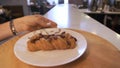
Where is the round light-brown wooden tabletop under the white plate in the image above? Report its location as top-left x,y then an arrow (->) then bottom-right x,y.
0,30 -> 120,68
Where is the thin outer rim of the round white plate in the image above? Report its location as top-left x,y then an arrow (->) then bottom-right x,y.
14,28 -> 87,67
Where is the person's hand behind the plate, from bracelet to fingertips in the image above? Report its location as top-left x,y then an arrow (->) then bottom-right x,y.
13,15 -> 57,32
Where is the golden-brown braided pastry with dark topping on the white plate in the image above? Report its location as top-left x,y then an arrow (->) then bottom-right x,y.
27,28 -> 77,52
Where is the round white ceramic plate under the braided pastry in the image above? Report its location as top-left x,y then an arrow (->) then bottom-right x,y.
14,28 -> 87,67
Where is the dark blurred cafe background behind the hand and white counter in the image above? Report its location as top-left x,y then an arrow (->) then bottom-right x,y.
0,0 -> 120,33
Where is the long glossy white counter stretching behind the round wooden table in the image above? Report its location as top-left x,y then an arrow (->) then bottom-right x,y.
44,4 -> 120,50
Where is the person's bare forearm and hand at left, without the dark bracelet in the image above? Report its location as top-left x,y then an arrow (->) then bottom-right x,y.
0,15 -> 57,40
